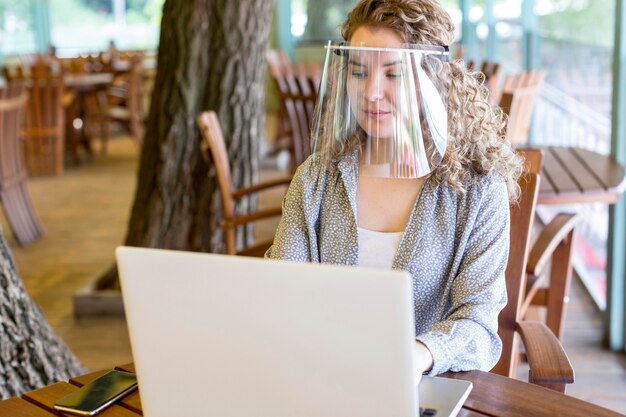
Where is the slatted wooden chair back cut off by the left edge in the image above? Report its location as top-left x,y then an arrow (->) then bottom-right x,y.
0,83 -> 43,246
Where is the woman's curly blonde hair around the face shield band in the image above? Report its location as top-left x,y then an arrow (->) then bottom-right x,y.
342,0 -> 522,201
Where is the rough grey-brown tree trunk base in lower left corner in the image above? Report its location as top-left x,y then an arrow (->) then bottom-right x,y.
0,229 -> 85,399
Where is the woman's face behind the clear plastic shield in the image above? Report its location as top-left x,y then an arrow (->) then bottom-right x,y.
347,26 -> 403,139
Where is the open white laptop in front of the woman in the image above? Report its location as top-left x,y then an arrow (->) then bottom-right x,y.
116,247 -> 472,417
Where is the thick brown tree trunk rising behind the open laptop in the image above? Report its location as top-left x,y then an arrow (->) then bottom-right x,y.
126,0 -> 273,252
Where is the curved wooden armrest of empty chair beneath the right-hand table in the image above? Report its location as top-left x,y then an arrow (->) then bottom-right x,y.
526,213 -> 581,277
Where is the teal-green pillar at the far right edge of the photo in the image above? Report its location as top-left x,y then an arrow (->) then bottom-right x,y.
605,0 -> 626,350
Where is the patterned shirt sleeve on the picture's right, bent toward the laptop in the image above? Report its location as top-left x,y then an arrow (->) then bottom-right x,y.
417,177 -> 510,375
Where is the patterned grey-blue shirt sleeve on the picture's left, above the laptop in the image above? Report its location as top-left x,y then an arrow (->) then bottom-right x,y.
265,158 -> 319,262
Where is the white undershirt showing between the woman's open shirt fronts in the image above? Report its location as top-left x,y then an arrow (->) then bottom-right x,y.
357,227 -> 402,269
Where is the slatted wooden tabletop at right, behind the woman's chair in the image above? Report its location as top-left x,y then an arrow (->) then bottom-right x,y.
537,146 -> 626,204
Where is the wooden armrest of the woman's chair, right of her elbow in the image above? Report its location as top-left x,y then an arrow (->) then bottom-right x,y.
517,321 -> 574,392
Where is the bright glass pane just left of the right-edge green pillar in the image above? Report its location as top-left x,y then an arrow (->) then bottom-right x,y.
534,0 -> 615,308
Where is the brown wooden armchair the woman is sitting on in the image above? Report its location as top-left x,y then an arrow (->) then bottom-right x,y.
492,150 -> 574,392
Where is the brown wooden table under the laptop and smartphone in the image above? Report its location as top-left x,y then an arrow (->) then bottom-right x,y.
0,364 -> 623,417
